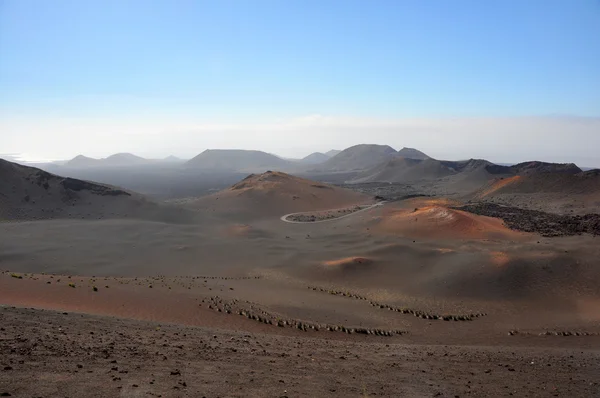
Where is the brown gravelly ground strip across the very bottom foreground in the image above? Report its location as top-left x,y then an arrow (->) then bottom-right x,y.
0,307 -> 600,397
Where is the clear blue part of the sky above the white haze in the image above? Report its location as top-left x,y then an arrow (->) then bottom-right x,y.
0,0 -> 600,162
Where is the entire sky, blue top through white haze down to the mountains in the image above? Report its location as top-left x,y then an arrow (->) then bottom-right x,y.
0,0 -> 600,166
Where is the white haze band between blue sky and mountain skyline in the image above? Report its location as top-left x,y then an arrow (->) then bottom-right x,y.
0,115 -> 600,167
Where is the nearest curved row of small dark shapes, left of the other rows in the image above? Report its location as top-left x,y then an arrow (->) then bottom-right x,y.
202,296 -> 407,337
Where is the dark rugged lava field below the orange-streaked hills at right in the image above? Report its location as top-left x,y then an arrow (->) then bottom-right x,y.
456,202 -> 600,237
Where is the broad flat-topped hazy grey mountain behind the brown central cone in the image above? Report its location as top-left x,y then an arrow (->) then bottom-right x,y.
186,149 -> 292,172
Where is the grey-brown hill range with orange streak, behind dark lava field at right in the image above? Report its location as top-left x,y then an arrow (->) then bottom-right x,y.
347,157 -> 600,214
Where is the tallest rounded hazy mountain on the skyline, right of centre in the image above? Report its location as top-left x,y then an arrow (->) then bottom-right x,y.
315,144 -> 397,171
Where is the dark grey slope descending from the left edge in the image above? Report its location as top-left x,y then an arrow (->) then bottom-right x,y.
0,159 -> 189,222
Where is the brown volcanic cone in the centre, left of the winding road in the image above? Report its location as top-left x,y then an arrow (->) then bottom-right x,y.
185,171 -> 372,220
